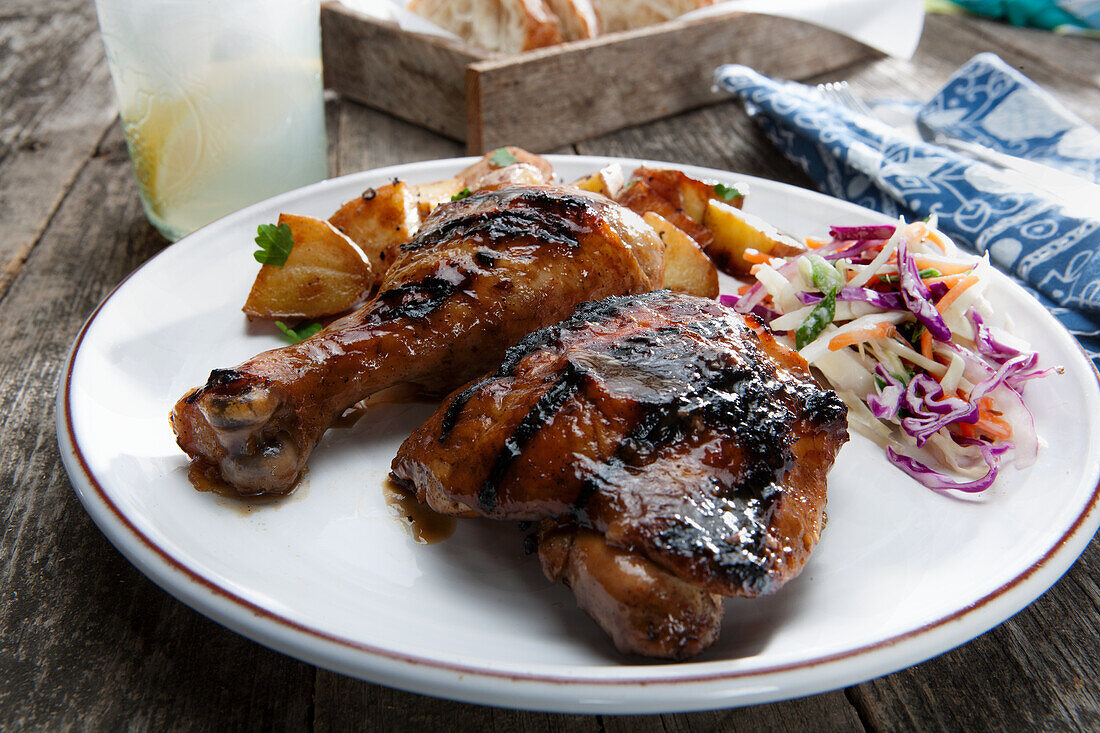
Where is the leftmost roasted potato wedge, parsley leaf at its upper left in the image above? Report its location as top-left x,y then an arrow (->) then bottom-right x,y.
242,214 -> 374,319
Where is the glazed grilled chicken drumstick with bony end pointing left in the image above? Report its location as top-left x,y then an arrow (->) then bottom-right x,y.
171,186 -> 663,494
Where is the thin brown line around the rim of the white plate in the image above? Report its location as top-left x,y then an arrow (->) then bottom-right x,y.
63,232 -> 1100,686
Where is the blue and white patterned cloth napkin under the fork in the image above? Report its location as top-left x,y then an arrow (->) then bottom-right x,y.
715,54 -> 1100,368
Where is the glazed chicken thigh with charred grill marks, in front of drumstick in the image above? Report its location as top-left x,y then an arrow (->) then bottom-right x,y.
393,291 -> 847,658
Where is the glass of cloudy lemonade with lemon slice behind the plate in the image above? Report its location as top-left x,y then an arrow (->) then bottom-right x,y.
96,0 -> 328,241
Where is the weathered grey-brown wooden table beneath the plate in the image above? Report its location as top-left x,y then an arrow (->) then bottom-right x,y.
0,0 -> 1100,732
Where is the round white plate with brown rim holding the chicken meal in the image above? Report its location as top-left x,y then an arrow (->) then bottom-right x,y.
57,156 -> 1100,713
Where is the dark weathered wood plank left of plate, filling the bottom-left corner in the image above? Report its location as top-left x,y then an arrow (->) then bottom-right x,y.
0,125 -> 314,731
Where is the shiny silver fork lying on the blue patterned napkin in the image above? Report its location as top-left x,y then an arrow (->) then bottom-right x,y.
817,81 -> 1100,214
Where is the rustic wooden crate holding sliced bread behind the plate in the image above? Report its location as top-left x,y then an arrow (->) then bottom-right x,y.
321,2 -> 877,153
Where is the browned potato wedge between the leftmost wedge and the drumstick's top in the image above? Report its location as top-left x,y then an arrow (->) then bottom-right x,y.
329,180 -> 420,282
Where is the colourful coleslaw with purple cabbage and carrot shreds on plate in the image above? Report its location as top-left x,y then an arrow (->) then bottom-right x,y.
722,218 -> 1062,493
